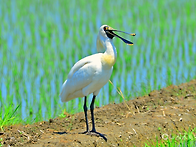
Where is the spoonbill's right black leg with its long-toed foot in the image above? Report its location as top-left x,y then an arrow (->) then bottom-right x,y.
90,95 -> 107,141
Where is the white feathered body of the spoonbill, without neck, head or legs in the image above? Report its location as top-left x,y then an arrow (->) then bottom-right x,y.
60,53 -> 112,102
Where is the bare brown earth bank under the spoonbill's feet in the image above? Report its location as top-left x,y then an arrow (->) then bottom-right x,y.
0,80 -> 196,147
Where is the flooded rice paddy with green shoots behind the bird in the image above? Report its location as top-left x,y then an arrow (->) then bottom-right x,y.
0,0 -> 196,124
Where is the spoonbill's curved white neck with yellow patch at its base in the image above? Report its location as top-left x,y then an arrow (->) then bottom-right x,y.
102,39 -> 117,67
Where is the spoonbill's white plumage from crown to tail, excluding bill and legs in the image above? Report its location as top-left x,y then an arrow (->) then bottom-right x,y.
60,25 -> 116,102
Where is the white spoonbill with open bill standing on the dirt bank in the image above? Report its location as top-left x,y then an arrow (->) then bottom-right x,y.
59,25 -> 136,141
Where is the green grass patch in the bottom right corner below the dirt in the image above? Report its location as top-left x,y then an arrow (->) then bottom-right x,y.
145,128 -> 196,147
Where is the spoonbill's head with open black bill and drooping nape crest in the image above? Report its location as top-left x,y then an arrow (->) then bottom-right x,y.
97,25 -> 136,52
